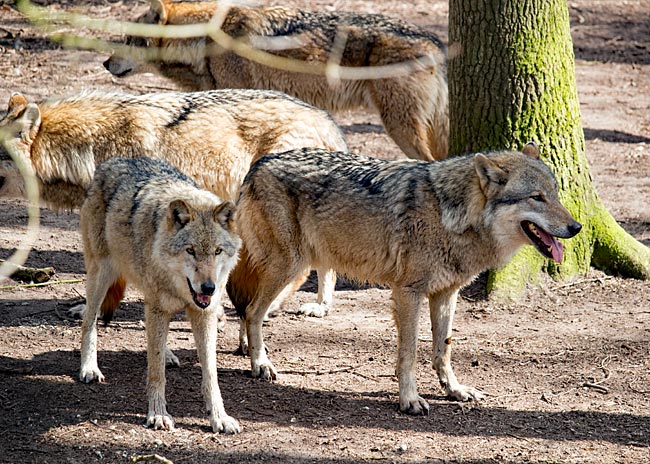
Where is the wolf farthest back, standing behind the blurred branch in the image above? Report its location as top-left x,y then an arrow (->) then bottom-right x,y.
104,0 -> 449,160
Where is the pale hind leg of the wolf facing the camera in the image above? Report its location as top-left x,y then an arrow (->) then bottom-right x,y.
79,258 -> 118,383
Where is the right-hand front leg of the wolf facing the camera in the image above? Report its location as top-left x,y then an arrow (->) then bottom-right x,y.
188,308 -> 241,434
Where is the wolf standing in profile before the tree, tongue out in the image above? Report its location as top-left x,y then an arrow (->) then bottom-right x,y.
227,145 -> 581,415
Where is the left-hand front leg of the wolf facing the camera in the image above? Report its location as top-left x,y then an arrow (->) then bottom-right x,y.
144,301 -> 174,430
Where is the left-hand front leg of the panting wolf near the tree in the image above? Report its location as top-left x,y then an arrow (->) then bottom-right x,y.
392,288 -> 429,415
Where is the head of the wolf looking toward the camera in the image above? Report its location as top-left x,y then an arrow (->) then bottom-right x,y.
157,196 -> 241,309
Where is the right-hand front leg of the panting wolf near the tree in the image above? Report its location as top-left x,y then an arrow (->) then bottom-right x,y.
429,289 -> 484,401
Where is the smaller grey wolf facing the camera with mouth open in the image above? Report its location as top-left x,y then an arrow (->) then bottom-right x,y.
79,158 -> 241,433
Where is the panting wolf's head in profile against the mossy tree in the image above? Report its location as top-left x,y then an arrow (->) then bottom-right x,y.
474,143 -> 582,263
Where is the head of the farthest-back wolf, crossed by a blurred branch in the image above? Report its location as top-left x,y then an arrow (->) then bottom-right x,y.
103,0 -> 218,77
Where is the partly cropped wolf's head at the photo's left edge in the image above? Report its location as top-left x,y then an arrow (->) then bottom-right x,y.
0,93 -> 41,196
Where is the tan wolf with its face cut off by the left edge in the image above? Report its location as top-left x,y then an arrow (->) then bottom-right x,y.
0,90 -> 347,318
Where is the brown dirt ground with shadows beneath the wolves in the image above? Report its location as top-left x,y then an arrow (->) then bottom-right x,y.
0,0 -> 650,464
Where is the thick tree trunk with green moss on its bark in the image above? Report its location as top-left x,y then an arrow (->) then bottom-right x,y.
449,0 -> 650,300
